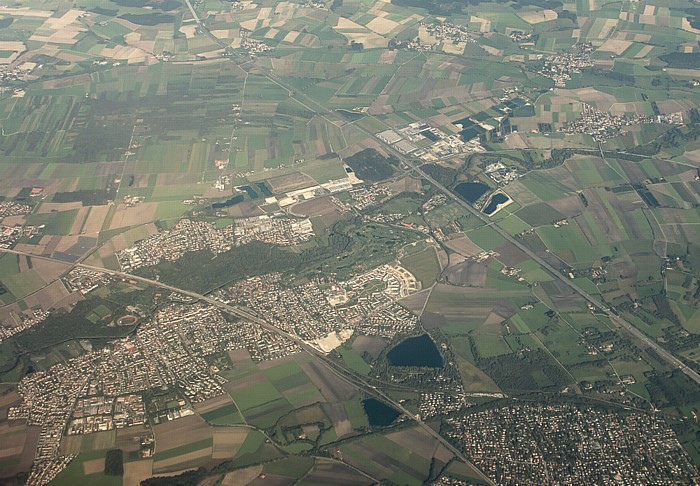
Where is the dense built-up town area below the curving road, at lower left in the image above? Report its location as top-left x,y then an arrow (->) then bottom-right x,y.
8,304 -> 299,484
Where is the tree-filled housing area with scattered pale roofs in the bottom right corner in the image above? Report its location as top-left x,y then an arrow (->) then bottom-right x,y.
447,403 -> 700,485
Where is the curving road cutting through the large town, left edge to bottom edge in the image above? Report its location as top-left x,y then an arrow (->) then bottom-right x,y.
0,249 -> 495,484
